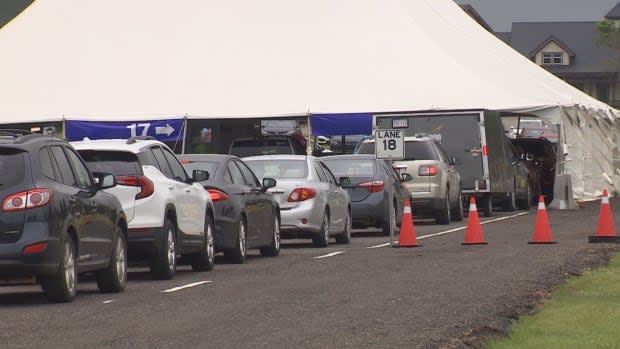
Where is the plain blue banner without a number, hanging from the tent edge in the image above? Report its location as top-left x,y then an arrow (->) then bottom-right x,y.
310,113 -> 372,136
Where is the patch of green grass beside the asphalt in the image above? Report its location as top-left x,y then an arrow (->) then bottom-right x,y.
487,254 -> 620,349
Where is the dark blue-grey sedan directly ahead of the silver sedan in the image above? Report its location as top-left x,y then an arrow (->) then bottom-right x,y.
323,154 -> 411,235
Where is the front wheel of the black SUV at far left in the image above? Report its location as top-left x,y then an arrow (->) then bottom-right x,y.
97,227 -> 127,292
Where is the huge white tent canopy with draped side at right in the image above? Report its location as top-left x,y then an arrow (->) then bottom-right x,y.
0,0 -> 620,198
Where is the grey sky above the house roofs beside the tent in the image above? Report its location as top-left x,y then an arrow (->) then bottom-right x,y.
455,0 -> 620,32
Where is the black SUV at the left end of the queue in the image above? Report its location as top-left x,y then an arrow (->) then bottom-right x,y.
0,131 -> 127,302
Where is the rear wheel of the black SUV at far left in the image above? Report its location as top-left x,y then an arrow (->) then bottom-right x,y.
42,236 -> 77,303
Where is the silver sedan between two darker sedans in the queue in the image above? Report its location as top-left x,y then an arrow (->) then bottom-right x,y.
243,155 -> 351,247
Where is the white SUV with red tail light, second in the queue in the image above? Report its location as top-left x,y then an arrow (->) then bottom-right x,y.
71,137 -> 215,279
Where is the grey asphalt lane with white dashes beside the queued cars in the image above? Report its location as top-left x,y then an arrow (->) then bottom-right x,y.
0,200 -> 620,349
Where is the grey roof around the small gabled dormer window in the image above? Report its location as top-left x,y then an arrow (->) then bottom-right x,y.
510,22 -> 618,74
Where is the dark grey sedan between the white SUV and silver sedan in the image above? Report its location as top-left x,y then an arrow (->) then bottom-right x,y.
180,154 -> 280,263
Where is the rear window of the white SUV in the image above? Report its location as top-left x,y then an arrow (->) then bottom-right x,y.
78,150 -> 142,176
